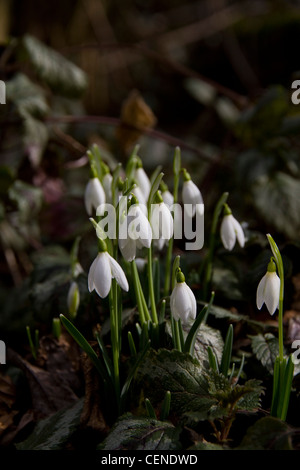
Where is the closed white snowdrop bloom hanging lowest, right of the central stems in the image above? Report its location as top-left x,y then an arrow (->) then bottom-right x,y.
170,270 -> 197,324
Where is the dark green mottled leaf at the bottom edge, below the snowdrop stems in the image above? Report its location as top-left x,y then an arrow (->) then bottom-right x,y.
97,413 -> 181,451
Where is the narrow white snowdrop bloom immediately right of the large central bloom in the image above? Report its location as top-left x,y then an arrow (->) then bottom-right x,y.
150,191 -> 173,248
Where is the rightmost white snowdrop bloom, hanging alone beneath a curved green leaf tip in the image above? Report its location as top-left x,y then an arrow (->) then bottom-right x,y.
256,260 -> 280,315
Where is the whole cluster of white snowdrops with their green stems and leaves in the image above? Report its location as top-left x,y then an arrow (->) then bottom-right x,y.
61,145 -> 293,419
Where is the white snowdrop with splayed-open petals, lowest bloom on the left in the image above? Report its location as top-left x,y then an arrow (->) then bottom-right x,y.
88,240 -> 129,298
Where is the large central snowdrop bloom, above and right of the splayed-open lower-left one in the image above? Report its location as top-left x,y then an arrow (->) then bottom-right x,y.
118,200 -> 152,261
